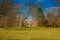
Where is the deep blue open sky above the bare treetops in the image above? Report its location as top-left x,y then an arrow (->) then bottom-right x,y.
13,0 -> 60,8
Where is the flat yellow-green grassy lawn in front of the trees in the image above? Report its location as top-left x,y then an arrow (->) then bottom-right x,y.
0,27 -> 60,40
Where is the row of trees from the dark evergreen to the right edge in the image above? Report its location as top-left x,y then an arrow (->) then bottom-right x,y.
34,8 -> 60,27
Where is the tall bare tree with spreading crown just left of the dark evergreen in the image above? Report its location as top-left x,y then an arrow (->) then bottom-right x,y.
28,2 -> 42,27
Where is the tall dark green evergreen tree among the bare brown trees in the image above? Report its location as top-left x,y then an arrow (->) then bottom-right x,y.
33,8 -> 45,27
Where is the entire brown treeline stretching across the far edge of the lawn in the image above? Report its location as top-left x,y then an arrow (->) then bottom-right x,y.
0,0 -> 60,27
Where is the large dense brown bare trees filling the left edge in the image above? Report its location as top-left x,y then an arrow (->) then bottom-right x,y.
0,0 -> 18,27
